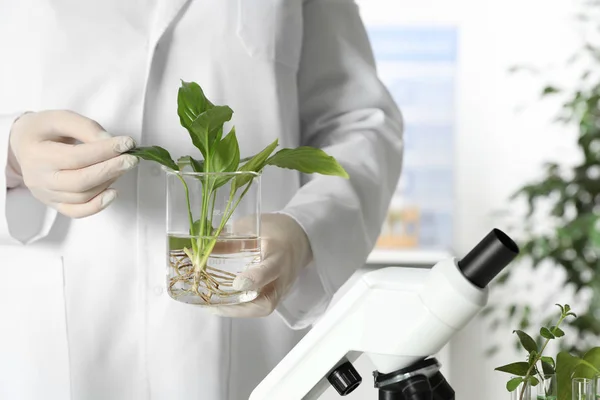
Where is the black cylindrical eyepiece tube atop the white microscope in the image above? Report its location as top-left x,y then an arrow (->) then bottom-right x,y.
458,229 -> 519,289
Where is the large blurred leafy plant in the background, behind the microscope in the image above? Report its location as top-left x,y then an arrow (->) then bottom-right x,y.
488,14 -> 600,351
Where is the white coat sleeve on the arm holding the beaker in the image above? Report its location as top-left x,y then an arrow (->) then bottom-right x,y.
276,0 -> 403,329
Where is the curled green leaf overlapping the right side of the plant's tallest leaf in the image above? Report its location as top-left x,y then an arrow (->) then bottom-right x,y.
189,106 -> 233,159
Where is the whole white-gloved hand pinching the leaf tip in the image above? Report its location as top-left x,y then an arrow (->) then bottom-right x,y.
8,111 -> 138,218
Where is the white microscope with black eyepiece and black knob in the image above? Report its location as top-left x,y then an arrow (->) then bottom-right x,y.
250,229 -> 519,400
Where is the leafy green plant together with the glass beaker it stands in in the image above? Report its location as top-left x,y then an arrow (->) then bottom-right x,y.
129,81 -> 348,305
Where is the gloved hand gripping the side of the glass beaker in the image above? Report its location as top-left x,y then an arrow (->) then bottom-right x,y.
208,214 -> 312,318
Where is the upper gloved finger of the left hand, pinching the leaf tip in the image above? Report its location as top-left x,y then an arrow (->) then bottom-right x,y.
46,136 -> 135,170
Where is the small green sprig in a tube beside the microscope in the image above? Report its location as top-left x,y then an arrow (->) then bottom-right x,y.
496,304 -> 576,400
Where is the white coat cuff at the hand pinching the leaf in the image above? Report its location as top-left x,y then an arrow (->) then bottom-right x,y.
0,113 -> 57,246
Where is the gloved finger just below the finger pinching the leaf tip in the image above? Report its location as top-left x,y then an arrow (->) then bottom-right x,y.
49,154 -> 139,192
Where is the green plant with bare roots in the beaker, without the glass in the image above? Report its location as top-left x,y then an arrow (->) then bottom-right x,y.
129,81 -> 348,303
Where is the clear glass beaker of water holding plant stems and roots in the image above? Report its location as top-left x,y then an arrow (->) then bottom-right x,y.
163,167 -> 261,306
